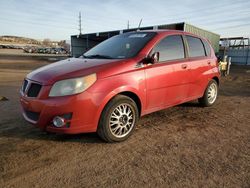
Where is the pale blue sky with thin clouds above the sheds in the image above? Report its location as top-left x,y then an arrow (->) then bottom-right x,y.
0,0 -> 250,40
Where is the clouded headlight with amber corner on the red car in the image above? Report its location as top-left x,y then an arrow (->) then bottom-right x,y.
49,74 -> 96,97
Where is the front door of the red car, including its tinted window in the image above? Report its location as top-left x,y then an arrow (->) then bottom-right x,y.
145,35 -> 189,112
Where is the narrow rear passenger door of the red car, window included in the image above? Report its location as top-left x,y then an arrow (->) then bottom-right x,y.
185,35 -> 211,99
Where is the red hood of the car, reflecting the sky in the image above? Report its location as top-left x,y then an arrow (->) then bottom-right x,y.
27,58 -> 127,85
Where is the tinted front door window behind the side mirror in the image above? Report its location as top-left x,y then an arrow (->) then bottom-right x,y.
154,35 -> 185,62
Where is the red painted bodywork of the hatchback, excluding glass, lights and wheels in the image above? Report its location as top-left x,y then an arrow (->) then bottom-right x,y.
20,31 -> 219,134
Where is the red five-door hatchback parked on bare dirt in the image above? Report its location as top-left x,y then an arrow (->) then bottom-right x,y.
20,30 -> 220,142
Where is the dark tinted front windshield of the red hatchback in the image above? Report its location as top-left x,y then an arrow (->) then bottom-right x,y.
83,32 -> 156,59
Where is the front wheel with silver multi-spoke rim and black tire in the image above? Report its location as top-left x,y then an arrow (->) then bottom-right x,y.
97,95 -> 139,142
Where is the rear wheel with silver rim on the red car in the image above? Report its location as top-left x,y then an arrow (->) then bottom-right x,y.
198,80 -> 218,107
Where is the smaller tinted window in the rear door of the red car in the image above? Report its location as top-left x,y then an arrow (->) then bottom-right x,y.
186,36 -> 205,57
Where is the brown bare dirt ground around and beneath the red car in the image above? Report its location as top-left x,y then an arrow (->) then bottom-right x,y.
0,56 -> 250,188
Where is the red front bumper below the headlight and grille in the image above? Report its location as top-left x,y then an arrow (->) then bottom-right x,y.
20,92 -> 98,134
